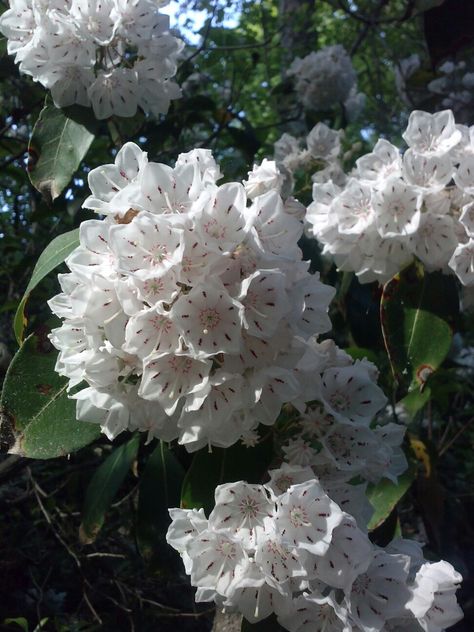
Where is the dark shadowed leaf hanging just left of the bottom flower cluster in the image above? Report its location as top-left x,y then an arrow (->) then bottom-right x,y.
136,441 -> 184,563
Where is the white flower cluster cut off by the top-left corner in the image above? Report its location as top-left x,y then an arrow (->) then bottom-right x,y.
0,0 -> 183,119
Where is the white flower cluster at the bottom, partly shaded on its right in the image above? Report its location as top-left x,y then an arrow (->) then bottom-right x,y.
167,478 -> 462,632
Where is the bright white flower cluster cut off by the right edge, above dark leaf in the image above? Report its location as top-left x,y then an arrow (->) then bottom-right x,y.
306,110 -> 474,285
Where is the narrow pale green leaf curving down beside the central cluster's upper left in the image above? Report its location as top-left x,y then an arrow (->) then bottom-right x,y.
13,228 -> 79,344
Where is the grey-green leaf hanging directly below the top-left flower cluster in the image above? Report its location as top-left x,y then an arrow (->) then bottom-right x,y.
28,97 -> 94,202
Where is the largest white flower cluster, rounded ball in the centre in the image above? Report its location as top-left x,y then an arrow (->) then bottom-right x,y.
49,143 -> 340,450
